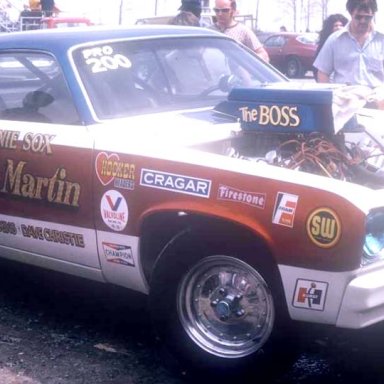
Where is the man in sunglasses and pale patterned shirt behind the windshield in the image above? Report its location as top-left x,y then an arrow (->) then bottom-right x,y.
212,0 -> 269,61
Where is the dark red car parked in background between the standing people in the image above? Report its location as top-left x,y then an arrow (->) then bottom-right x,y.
264,32 -> 318,78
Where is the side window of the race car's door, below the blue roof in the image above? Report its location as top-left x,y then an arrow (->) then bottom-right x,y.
0,52 -> 80,124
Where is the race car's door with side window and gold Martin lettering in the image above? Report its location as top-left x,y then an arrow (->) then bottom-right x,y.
0,51 -> 100,274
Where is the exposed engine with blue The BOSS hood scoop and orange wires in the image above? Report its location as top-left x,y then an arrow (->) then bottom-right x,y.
215,83 -> 384,189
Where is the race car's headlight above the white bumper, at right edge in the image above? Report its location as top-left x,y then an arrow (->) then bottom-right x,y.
362,211 -> 384,265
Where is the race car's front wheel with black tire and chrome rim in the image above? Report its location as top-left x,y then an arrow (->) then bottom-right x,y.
150,232 -> 297,379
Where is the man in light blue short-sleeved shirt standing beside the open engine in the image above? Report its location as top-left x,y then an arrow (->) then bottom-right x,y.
314,0 -> 384,87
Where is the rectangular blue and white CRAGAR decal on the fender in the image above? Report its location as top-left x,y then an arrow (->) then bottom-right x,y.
140,168 -> 212,198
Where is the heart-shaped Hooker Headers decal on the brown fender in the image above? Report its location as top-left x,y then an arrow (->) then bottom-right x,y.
95,152 -> 135,190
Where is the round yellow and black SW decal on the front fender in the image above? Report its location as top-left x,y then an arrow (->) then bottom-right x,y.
307,208 -> 341,248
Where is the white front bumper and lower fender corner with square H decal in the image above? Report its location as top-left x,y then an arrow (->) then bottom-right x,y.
279,262 -> 384,328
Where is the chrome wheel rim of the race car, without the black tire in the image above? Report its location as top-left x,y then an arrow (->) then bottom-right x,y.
177,256 -> 275,358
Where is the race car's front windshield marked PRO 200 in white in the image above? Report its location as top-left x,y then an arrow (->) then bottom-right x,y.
73,37 -> 286,119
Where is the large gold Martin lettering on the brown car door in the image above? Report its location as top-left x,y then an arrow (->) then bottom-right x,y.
0,159 -> 81,207
